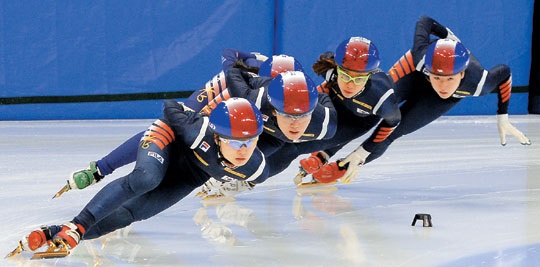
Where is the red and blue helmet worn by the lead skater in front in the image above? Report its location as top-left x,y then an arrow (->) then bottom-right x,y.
209,97 -> 264,139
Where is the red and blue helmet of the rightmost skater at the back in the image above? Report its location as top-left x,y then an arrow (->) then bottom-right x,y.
424,39 -> 470,76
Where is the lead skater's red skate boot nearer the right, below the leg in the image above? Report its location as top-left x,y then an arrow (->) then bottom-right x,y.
32,222 -> 85,259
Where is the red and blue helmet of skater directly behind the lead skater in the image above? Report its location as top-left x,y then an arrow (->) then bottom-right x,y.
268,71 -> 319,116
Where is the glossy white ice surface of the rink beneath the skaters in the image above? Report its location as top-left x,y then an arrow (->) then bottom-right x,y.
0,115 -> 540,267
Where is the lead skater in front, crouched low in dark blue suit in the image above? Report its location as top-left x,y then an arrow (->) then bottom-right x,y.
8,98 -> 268,258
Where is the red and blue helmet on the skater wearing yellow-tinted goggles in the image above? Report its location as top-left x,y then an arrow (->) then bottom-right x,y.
334,37 -> 381,72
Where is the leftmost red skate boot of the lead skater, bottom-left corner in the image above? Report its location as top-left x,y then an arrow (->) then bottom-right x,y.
6,225 -> 61,258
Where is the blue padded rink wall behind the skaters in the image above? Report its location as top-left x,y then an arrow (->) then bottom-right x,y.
0,0 -> 534,120
